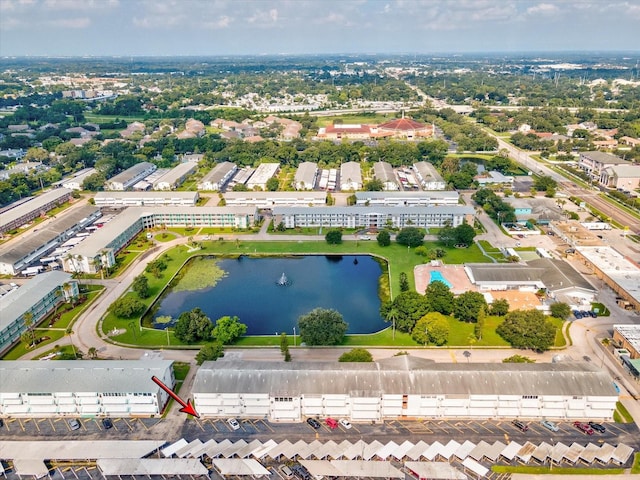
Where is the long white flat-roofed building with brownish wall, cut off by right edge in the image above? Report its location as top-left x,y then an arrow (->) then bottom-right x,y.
575,246 -> 640,310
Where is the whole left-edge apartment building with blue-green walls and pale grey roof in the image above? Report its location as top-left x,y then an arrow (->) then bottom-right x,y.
0,271 -> 79,354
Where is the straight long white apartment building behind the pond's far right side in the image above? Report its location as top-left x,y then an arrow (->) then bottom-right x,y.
273,206 -> 475,230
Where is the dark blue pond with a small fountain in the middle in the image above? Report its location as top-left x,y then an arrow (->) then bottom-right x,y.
154,255 -> 387,335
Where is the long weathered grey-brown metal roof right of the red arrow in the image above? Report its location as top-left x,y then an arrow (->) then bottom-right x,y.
192,356 -> 618,397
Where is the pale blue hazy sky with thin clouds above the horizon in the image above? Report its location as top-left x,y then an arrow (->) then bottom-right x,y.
0,0 -> 640,56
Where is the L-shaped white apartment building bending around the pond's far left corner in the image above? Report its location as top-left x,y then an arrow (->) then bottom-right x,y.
62,206 -> 258,273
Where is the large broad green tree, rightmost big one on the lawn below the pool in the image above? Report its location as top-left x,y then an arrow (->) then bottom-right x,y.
496,310 -> 556,352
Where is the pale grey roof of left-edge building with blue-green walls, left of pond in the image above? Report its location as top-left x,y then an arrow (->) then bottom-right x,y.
0,270 -> 72,330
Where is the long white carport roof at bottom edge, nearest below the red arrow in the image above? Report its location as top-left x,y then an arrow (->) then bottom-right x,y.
97,458 -> 209,478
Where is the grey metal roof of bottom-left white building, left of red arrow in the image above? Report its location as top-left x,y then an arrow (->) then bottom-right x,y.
0,360 -> 173,394
